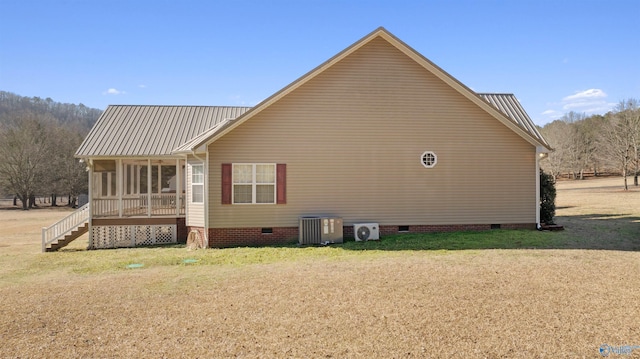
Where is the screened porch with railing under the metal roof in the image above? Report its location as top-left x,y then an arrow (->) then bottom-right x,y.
89,159 -> 185,218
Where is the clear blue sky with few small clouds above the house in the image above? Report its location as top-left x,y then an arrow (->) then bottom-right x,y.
0,0 -> 640,126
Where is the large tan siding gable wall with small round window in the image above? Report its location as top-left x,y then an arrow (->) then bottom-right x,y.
208,39 -> 536,228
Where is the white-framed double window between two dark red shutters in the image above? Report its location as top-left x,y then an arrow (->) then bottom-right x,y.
233,163 -> 276,204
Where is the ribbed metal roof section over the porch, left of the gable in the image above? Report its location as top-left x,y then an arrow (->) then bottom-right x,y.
76,105 -> 251,157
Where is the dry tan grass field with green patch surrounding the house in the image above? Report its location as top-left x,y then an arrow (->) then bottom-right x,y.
0,178 -> 640,358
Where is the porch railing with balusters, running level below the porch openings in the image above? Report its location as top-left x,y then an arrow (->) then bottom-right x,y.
92,193 -> 185,217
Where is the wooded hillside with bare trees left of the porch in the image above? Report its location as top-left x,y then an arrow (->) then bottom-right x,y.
0,91 -> 102,209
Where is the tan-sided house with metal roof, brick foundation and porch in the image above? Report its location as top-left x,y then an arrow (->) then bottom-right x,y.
43,28 -> 550,252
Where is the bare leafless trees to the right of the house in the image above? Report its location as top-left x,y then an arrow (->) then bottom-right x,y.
540,98 -> 640,190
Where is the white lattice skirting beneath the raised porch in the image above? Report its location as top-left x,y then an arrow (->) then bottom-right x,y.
90,224 -> 178,249
